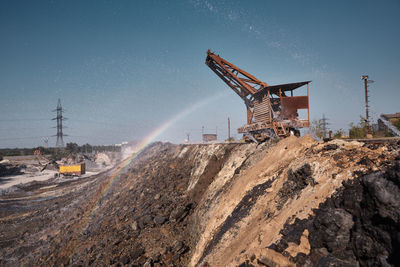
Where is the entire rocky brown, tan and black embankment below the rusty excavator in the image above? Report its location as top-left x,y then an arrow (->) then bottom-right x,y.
0,136 -> 400,266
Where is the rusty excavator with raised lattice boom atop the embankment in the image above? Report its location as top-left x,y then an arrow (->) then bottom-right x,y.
206,50 -> 311,143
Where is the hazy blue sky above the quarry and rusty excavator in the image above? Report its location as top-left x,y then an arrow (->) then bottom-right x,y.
0,0 -> 400,148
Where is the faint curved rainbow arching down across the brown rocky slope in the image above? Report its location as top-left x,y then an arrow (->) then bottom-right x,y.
67,93 -> 224,259
